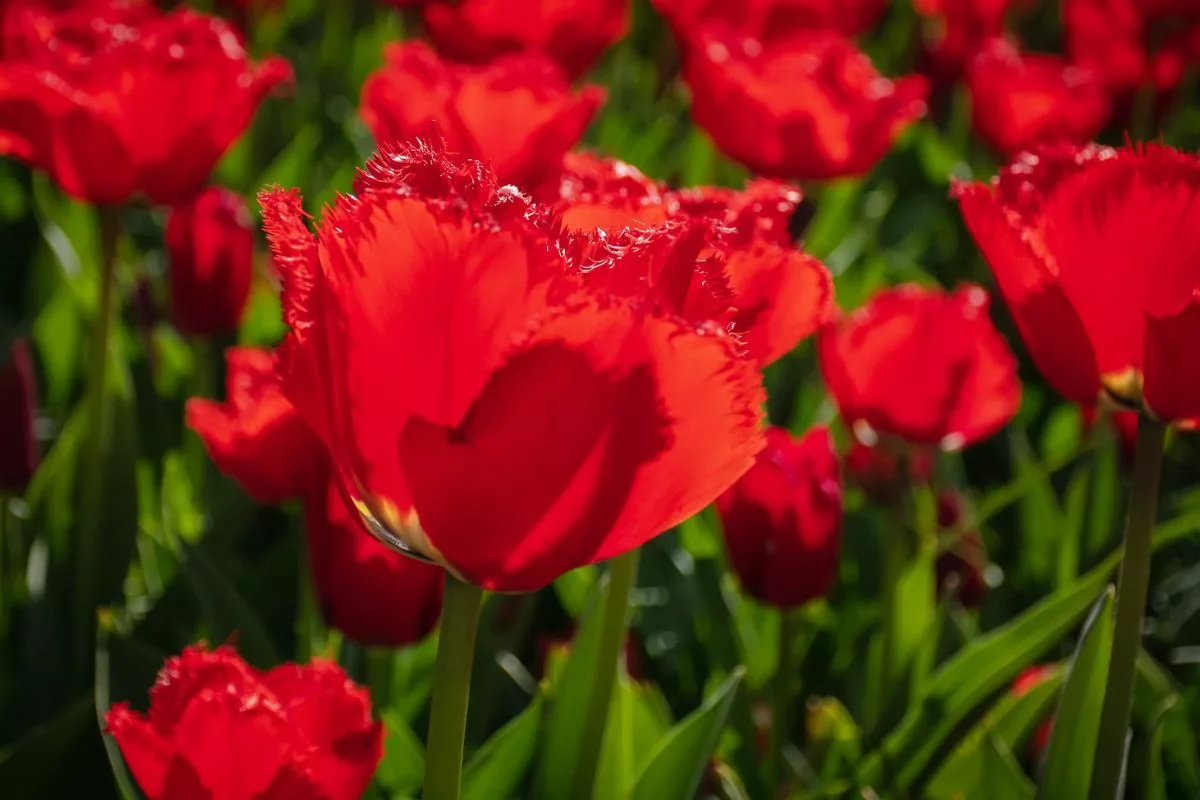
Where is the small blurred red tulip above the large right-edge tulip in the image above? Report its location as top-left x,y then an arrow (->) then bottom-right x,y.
967,38 -> 1112,156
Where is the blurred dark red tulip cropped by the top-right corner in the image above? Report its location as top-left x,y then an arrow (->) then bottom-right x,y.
1063,0 -> 1200,98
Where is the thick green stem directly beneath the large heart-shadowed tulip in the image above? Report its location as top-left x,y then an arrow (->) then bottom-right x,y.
421,572 -> 484,800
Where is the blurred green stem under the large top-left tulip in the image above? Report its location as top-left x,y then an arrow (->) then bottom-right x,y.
73,205 -> 121,682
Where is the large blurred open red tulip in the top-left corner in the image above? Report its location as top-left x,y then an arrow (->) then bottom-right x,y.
0,0 -> 290,204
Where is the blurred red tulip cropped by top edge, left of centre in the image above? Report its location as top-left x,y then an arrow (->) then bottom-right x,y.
422,0 -> 629,77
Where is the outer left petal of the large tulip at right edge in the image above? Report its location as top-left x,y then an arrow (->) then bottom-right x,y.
954,184 -> 1100,407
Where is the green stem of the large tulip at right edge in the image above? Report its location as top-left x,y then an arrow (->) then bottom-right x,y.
1091,416 -> 1166,800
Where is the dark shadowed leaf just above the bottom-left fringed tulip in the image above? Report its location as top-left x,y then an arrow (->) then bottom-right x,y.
180,543 -> 280,669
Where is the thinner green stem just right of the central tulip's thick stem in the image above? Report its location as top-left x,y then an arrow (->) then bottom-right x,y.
568,549 -> 640,800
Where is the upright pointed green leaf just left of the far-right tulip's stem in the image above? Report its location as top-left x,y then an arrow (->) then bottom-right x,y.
1038,587 -> 1116,798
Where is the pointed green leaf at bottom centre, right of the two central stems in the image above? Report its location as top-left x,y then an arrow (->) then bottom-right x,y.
629,667 -> 745,800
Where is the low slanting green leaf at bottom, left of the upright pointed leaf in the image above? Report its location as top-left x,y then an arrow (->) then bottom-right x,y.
925,669 -> 1063,800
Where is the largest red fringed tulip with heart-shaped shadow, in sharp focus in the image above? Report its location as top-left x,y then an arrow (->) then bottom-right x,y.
262,137 -> 763,591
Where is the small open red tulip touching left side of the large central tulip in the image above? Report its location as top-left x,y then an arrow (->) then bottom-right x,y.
187,348 -> 329,504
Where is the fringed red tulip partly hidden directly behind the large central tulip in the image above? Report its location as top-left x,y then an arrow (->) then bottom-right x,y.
554,152 -> 833,365
